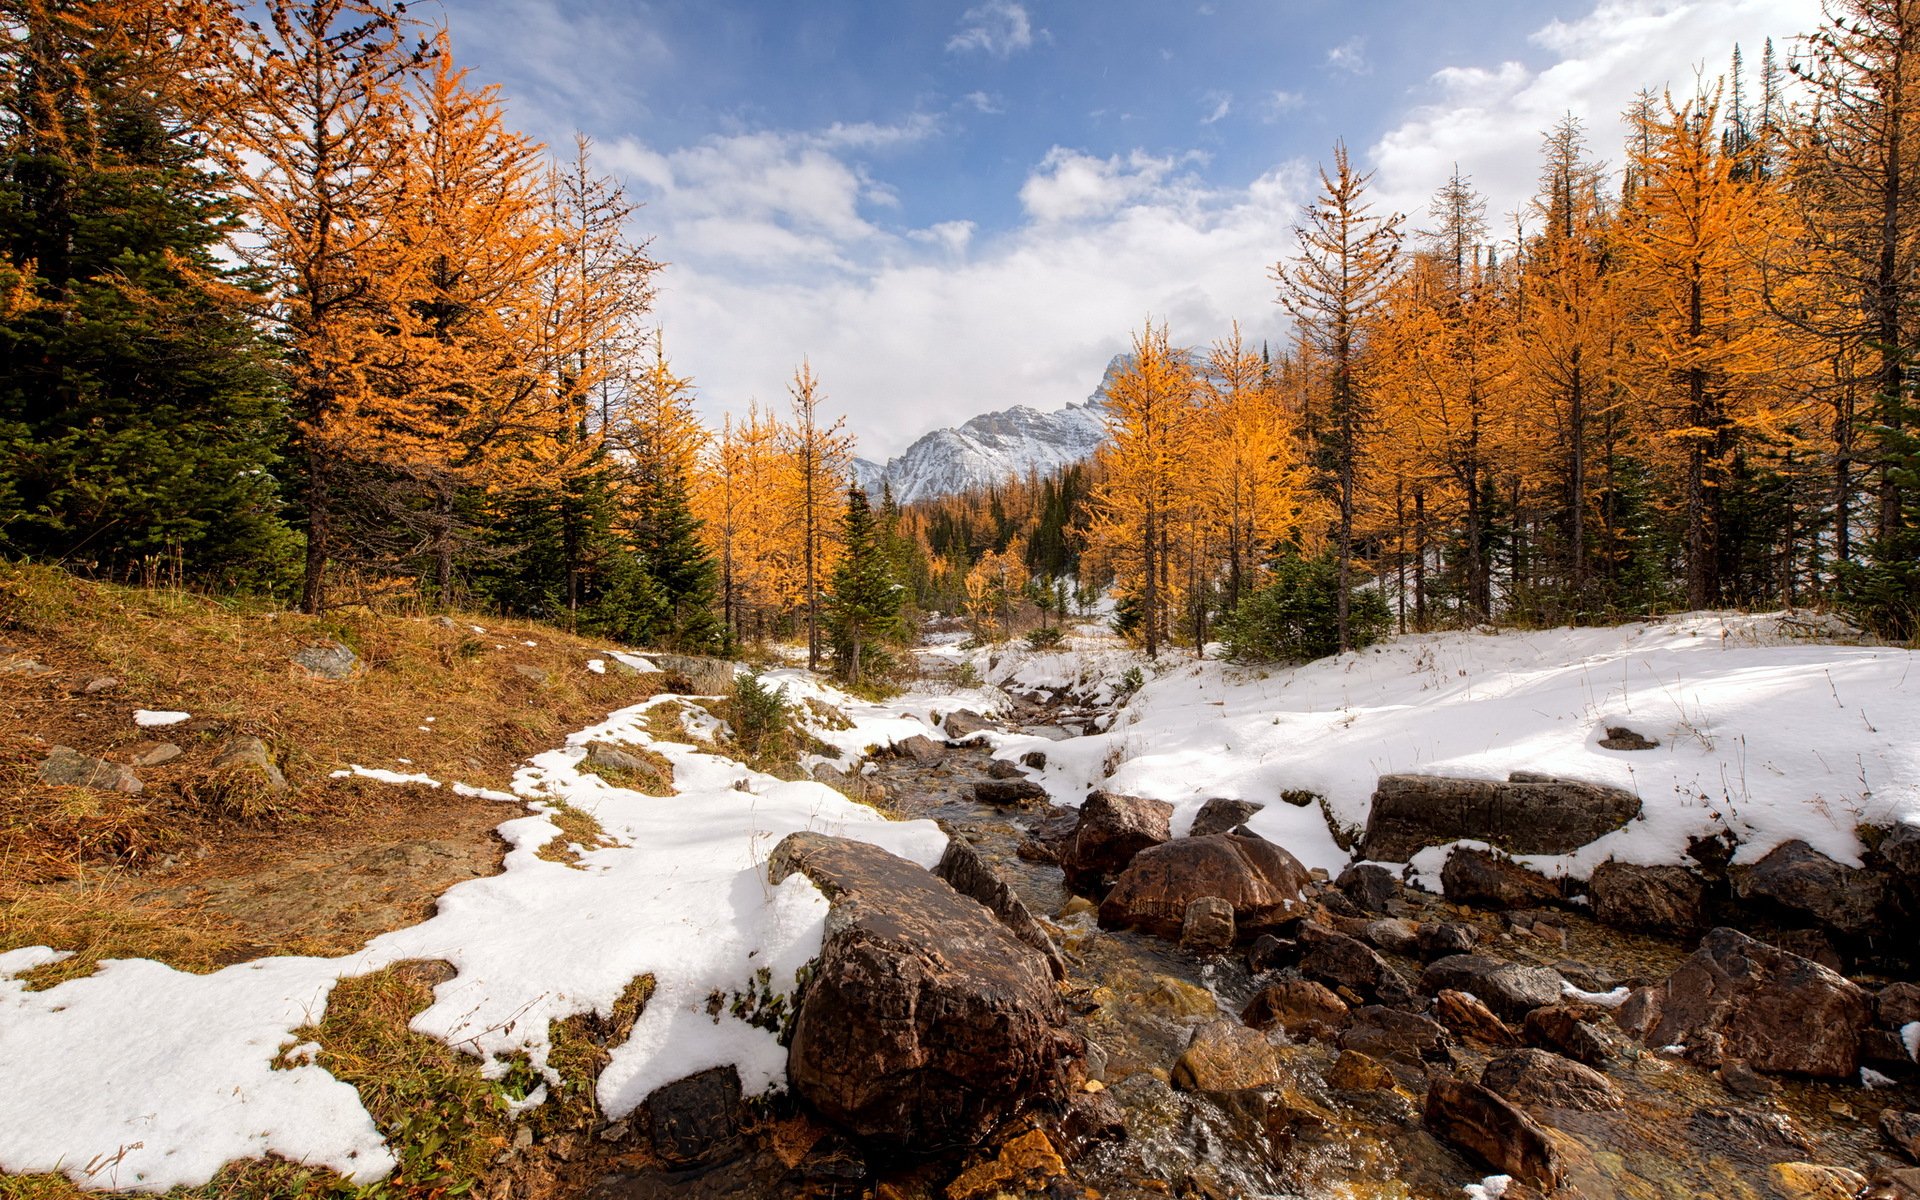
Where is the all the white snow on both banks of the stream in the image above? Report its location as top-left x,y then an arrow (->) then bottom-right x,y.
0,614 -> 1920,1190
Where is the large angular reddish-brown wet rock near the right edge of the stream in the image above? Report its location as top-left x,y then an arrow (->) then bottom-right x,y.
1619,929 -> 1870,1079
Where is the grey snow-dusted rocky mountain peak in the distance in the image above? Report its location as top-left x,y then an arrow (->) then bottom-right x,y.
852,355 -> 1127,505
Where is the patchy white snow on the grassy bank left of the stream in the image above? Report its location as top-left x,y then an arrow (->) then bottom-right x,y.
0,655 -> 952,1190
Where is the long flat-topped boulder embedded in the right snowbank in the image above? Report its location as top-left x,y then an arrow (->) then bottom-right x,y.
1361,776 -> 1640,862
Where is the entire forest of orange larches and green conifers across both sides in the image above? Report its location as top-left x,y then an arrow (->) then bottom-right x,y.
0,0 -> 1920,674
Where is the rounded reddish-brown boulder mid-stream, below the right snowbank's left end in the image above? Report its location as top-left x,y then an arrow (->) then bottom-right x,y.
1100,833 -> 1309,937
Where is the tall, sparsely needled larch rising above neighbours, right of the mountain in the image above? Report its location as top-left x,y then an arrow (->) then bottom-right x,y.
1273,142 -> 1402,649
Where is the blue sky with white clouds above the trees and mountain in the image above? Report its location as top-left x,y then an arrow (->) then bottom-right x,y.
439,0 -> 1820,459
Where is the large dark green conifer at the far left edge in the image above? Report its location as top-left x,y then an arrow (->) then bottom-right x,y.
0,0 -> 294,588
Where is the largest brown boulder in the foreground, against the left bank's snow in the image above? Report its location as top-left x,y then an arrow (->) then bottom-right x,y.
768,831 -> 1081,1152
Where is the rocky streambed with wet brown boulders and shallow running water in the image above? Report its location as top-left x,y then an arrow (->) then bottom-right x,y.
595,679 -> 1920,1200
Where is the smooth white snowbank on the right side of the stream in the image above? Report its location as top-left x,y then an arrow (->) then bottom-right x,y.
973,614 -> 1920,877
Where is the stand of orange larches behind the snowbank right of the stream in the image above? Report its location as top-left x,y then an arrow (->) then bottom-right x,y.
1087,11 -> 1920,649
